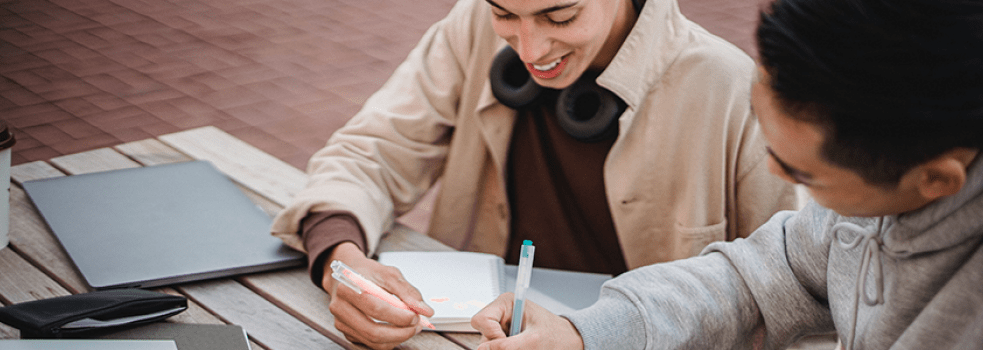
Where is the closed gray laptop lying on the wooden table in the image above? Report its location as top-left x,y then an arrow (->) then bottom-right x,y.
23,161 -> 306,290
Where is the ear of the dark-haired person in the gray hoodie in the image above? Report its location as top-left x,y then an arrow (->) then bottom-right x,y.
915,148 -> 978,200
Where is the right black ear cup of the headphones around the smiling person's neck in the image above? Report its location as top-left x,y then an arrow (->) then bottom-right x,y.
556,73 -> 627,142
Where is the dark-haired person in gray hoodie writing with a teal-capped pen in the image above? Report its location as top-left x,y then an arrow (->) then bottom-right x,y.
471,0 -> 983,350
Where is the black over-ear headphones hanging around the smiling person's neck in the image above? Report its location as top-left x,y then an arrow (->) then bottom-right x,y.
489,0 -> 645,142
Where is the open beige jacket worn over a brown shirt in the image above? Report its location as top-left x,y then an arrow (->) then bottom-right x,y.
272,0 -> 795,268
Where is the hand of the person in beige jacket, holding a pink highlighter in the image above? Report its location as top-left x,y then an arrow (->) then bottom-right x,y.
321,242 -> 433,350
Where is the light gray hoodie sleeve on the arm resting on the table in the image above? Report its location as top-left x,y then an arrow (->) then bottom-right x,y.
567,202 -> 833,350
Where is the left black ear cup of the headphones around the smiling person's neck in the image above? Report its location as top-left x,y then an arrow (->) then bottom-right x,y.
488,46 -> 543,109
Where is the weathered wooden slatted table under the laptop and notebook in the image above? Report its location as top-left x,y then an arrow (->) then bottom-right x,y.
0,127 -> 479,350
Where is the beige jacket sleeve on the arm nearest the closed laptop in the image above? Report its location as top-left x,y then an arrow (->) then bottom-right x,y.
271,0 -> 487,255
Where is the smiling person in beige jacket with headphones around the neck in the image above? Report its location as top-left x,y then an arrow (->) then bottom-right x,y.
273,0 -> 796,349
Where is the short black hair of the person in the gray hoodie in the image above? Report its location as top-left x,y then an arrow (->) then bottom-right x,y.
757,0 -> 983,187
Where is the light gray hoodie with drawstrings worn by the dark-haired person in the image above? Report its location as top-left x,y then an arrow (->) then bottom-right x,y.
567,156 -> 983,350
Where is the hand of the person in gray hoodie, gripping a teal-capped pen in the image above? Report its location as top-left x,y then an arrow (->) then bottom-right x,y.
471,293 -> 584,350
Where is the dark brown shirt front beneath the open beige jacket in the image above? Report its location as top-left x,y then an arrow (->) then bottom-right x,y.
505,92 -> 628,275
